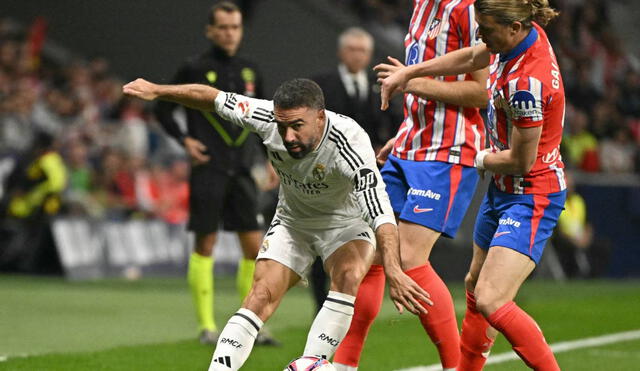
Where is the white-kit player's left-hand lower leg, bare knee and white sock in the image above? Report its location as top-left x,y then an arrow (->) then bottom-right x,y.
209,259 -> 300,371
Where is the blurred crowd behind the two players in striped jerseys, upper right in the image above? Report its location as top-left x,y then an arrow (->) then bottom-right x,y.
338,0 -> 640,173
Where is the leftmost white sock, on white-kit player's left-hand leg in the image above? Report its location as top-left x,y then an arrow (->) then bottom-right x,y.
209,308 -> 263,371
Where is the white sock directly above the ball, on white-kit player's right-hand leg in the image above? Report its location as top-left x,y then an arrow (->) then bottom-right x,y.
303,291 -> 356,359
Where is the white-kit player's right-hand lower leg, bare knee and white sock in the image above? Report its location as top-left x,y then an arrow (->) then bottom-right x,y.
304,240 -> 374,359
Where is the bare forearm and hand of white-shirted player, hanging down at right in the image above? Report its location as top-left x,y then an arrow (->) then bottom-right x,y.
376,223 -> 433,315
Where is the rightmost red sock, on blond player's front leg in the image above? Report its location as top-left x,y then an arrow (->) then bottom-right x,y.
487,301 -> 560,371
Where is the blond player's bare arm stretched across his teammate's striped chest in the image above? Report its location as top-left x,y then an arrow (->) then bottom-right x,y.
374,43 -> 490,110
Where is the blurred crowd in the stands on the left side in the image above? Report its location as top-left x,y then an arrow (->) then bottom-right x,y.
0,19 -> 189,224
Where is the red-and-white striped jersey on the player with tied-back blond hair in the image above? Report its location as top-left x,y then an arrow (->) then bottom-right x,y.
487,23 -> 566,194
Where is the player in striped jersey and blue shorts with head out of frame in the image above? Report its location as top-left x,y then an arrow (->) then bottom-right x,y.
334,0 -> 488,370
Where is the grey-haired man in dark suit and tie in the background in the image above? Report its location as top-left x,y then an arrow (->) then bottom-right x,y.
312,27 -> 402,150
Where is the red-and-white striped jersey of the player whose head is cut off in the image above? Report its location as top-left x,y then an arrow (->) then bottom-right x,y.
392,0 -> 484,166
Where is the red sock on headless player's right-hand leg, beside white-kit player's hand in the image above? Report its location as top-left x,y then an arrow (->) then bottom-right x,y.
405,263 -> 460,369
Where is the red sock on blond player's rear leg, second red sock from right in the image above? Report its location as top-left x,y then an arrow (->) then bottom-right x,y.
458,291 -> 494,371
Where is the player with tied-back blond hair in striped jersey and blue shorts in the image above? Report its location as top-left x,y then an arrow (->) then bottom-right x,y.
381,0 -> 566,371
